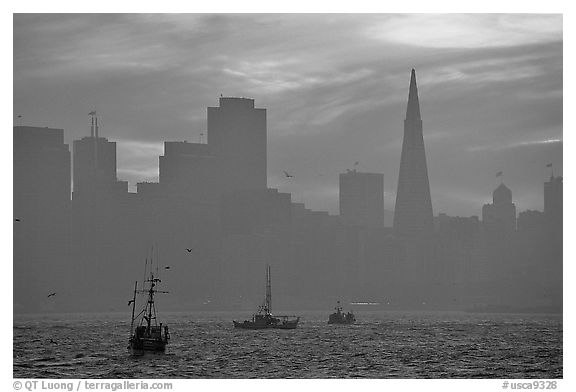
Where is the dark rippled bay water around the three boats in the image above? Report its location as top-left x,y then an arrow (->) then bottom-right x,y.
13,311 -> 562,379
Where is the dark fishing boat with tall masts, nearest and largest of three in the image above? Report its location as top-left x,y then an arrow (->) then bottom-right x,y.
128,258 -> 170,355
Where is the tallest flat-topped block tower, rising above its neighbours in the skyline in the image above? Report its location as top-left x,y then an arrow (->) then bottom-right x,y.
208,97 -> 267,190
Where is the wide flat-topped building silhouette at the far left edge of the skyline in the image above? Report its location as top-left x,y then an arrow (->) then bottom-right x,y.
13,126 -> 70,311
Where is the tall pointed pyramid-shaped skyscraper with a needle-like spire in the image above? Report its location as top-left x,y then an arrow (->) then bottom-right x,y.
394,69 -> 433,238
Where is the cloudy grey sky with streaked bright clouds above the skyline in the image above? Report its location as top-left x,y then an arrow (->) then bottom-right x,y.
13,14 -> 563,217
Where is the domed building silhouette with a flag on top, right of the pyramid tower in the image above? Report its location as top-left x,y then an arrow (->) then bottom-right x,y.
482,183 -> 516,236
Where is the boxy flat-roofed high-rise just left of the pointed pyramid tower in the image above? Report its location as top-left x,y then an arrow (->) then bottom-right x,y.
340,170 -> 384,228
